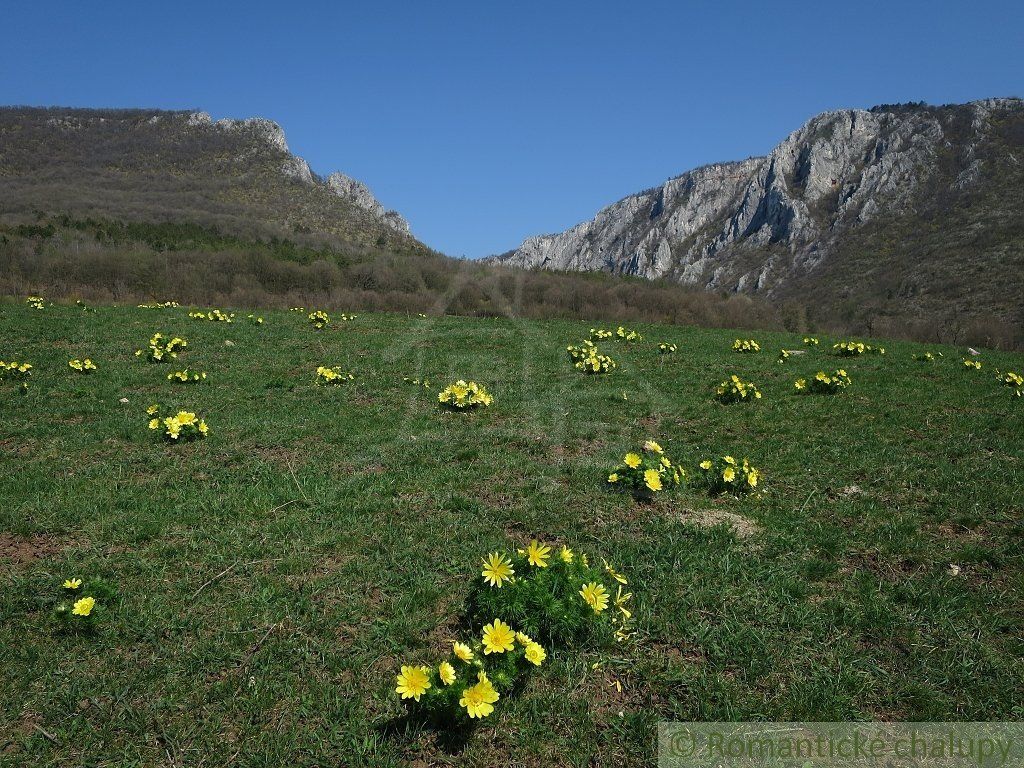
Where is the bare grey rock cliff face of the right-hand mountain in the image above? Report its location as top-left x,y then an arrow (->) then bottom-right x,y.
492,99 -> 1024,296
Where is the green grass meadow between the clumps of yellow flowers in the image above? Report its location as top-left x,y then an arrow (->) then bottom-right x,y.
0,302 -> 1024,766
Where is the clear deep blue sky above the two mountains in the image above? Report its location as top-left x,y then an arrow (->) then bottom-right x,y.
0,0 -> 1024,257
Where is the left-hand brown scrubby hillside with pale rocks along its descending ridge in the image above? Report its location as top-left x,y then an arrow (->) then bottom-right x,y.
0,108 -> 426,252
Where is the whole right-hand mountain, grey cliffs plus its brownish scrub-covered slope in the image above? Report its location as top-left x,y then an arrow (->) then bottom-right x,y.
494,99 -> 1024,342
